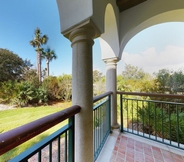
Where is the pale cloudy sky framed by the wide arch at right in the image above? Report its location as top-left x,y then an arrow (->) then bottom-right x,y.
118,22 -> 184,74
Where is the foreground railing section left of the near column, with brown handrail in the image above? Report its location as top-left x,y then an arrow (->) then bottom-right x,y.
0,106 -> 81,162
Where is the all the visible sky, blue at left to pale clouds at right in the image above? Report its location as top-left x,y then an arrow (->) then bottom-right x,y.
0,0 -> 184,75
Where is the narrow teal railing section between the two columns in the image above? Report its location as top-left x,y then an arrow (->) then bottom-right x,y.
93,92 -> 112,160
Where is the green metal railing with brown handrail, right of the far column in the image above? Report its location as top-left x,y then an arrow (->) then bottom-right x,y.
117,92 -> 184,150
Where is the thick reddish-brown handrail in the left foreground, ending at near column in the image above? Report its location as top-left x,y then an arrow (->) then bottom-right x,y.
0,105 -> 81,155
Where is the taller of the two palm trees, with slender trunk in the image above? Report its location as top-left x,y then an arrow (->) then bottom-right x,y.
30,27 -> 48,82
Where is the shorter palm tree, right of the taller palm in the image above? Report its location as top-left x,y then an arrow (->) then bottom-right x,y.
42,47 -> 57,76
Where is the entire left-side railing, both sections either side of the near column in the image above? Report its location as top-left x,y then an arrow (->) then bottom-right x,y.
0,92 -> 112,162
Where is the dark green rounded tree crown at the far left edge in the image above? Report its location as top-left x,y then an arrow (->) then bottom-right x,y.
0,48 -> 32,82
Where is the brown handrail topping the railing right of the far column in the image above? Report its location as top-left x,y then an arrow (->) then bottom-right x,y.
117,91 -> 184,99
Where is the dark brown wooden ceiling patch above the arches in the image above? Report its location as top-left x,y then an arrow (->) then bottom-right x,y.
116,0 -> 147,12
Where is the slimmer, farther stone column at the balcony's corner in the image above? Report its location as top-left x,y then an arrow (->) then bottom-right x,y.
104,58 -> 119,129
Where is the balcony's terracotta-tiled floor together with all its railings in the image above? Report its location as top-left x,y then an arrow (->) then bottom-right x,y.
0,92 -> 184,162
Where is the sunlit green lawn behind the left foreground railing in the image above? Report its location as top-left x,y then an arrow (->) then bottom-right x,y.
0,102 -> 71,162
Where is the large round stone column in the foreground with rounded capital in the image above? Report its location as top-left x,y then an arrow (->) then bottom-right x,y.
69,27 -> 95,162
